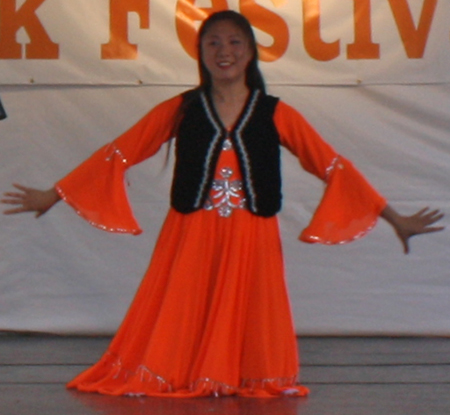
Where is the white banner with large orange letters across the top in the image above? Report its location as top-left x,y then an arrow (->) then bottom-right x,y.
0,0 -> 450,85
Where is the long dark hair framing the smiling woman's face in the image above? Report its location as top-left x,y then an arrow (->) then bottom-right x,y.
197,10 -> 266,92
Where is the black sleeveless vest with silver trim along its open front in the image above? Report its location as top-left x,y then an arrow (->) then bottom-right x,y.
171,90 -> 281,217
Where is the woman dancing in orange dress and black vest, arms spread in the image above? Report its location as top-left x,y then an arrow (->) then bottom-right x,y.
3,11 -> 443,397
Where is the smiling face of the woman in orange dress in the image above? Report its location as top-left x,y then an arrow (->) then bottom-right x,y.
200,20 -> 253,85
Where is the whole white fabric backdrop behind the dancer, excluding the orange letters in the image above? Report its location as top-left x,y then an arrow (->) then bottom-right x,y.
0,0 -> 450,335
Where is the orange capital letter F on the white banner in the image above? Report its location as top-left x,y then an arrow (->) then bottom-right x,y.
102,0 -> 150,59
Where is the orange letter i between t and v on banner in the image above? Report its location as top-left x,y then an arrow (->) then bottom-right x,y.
347,0 -> 380,59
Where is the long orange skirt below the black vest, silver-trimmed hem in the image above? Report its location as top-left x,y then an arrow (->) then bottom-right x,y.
67,148 -> 308,397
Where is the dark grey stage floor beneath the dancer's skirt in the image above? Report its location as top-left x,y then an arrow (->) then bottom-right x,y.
0,334 -> 450,415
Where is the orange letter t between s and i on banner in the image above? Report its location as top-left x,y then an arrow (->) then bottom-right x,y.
303,0 -> 340,61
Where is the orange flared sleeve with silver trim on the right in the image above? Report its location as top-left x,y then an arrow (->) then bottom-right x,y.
274,101 -> 386,244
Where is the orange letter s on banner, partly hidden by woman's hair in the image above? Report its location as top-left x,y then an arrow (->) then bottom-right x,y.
240,0 -> 289,62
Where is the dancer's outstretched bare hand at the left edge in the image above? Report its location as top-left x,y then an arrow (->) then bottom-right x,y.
0,184 -> 60,218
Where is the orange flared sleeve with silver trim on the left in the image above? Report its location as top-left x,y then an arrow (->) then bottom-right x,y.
55,96 -> 182,235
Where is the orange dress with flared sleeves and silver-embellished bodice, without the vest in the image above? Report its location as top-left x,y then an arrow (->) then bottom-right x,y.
56,93 -> 385,397
